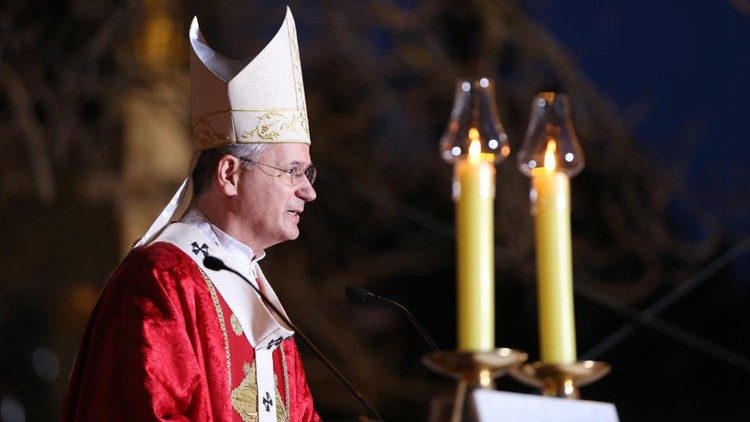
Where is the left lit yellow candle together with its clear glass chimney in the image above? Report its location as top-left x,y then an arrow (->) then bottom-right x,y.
440,78 -> 510,352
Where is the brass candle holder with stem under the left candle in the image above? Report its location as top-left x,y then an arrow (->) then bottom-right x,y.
422,348 -> 528,422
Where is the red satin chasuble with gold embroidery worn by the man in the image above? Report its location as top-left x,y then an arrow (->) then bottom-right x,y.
62,242 -> 320,421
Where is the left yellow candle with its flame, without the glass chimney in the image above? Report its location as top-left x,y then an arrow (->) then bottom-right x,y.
453,129 -> 495,351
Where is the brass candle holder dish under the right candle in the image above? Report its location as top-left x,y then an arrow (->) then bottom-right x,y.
511,360 -> 612,399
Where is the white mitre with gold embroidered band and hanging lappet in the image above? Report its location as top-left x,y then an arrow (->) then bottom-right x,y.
134,7 -> 310,247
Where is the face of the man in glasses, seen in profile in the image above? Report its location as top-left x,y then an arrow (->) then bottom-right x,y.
235,143 -> 316,253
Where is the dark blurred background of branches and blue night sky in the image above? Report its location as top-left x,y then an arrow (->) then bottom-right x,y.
0,0 -> 750,421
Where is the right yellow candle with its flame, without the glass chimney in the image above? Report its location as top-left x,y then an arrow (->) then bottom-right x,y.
531,140 -> 576,363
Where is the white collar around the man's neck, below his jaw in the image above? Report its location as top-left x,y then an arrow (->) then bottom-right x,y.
180,207 -> 266,278
